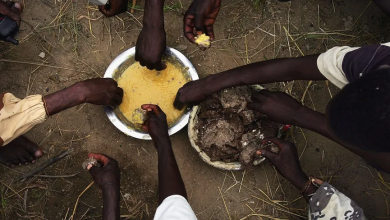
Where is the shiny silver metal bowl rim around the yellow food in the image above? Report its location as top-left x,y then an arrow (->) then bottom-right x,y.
104,47 -> 199,140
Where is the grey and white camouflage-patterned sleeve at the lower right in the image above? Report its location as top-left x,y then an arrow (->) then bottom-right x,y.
309,182 -> 366,220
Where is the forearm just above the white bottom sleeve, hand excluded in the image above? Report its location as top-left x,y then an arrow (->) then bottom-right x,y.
157,137 -> 187,203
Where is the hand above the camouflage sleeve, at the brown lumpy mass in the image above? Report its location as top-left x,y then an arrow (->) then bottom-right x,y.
256,138 -> 309,190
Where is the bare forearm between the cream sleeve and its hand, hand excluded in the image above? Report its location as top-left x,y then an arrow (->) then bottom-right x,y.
44,83 -> 84,115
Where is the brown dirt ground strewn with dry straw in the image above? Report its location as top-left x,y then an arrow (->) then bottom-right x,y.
0,0 -> 390,220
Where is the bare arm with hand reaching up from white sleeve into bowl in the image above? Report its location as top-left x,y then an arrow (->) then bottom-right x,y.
142,105 -> 187,204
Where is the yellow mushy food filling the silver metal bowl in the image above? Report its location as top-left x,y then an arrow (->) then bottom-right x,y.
118,62 -> 188,127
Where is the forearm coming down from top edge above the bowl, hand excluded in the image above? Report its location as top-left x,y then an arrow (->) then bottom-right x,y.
143,0 -> 164,27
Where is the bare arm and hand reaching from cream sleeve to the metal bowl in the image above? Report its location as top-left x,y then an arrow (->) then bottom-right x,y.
44,78 -> 123,115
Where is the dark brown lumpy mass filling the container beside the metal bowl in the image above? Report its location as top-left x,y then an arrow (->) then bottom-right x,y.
195,86 -> 280,167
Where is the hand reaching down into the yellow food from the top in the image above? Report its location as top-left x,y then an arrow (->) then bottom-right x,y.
135,25 -> 166,70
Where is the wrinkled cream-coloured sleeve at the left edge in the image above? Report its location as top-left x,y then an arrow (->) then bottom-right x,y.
0,93 -> 46,146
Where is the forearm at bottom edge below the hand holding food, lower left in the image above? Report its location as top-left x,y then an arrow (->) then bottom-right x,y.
102,185 -> 120,220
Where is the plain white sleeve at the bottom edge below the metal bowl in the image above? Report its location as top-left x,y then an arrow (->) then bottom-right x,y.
154,195 -> 197,220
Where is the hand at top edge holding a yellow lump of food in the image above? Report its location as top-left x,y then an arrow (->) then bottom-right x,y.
184,0 -> 221,43
